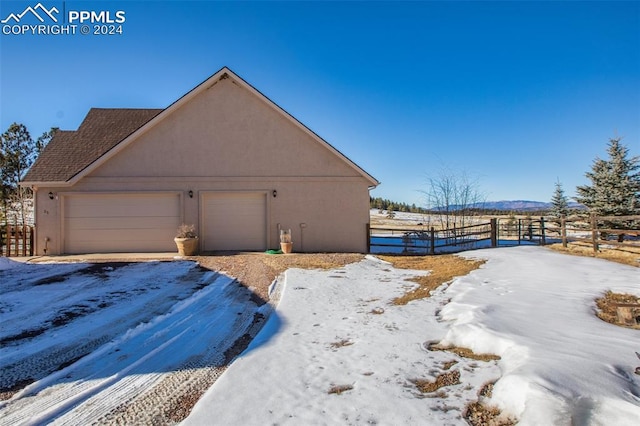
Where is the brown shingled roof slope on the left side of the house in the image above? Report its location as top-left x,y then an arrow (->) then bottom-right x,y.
23,108 -> 163,182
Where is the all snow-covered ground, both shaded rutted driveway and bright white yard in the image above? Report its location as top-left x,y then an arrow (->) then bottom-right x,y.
0,247 -> 640,426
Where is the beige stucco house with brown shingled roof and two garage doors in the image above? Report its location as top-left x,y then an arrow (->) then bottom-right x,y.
21,67 -> 379,255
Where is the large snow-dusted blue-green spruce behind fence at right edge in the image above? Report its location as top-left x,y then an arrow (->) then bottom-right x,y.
576,138 -> 640,216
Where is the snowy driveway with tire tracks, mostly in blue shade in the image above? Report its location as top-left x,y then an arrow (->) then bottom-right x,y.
0,258 -> 270,425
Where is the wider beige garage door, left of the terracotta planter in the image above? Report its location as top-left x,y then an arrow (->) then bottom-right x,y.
64,193 -> 181,253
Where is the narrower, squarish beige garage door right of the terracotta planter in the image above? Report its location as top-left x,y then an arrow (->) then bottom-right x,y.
202,192 -> 267,251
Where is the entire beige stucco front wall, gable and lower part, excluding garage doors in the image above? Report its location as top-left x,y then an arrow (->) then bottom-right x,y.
36,75 -> 371,254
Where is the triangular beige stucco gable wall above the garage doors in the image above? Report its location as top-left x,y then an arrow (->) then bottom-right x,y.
91,79 -> 358,177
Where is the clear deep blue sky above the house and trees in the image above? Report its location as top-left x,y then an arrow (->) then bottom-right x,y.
0,0 -> 640,205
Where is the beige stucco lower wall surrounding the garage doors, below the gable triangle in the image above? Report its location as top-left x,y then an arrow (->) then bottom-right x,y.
36,178 -> 369,254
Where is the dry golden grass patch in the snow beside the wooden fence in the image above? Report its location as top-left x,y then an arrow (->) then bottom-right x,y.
378,254 -> 485,305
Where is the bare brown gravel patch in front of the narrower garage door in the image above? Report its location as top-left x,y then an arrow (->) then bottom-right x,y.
194,253 -> 364,303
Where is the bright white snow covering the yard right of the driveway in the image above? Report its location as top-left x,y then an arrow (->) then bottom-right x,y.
183,247 -> 640,425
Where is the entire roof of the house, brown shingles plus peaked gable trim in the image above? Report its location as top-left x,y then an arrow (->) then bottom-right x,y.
22,67 -> 380,187
